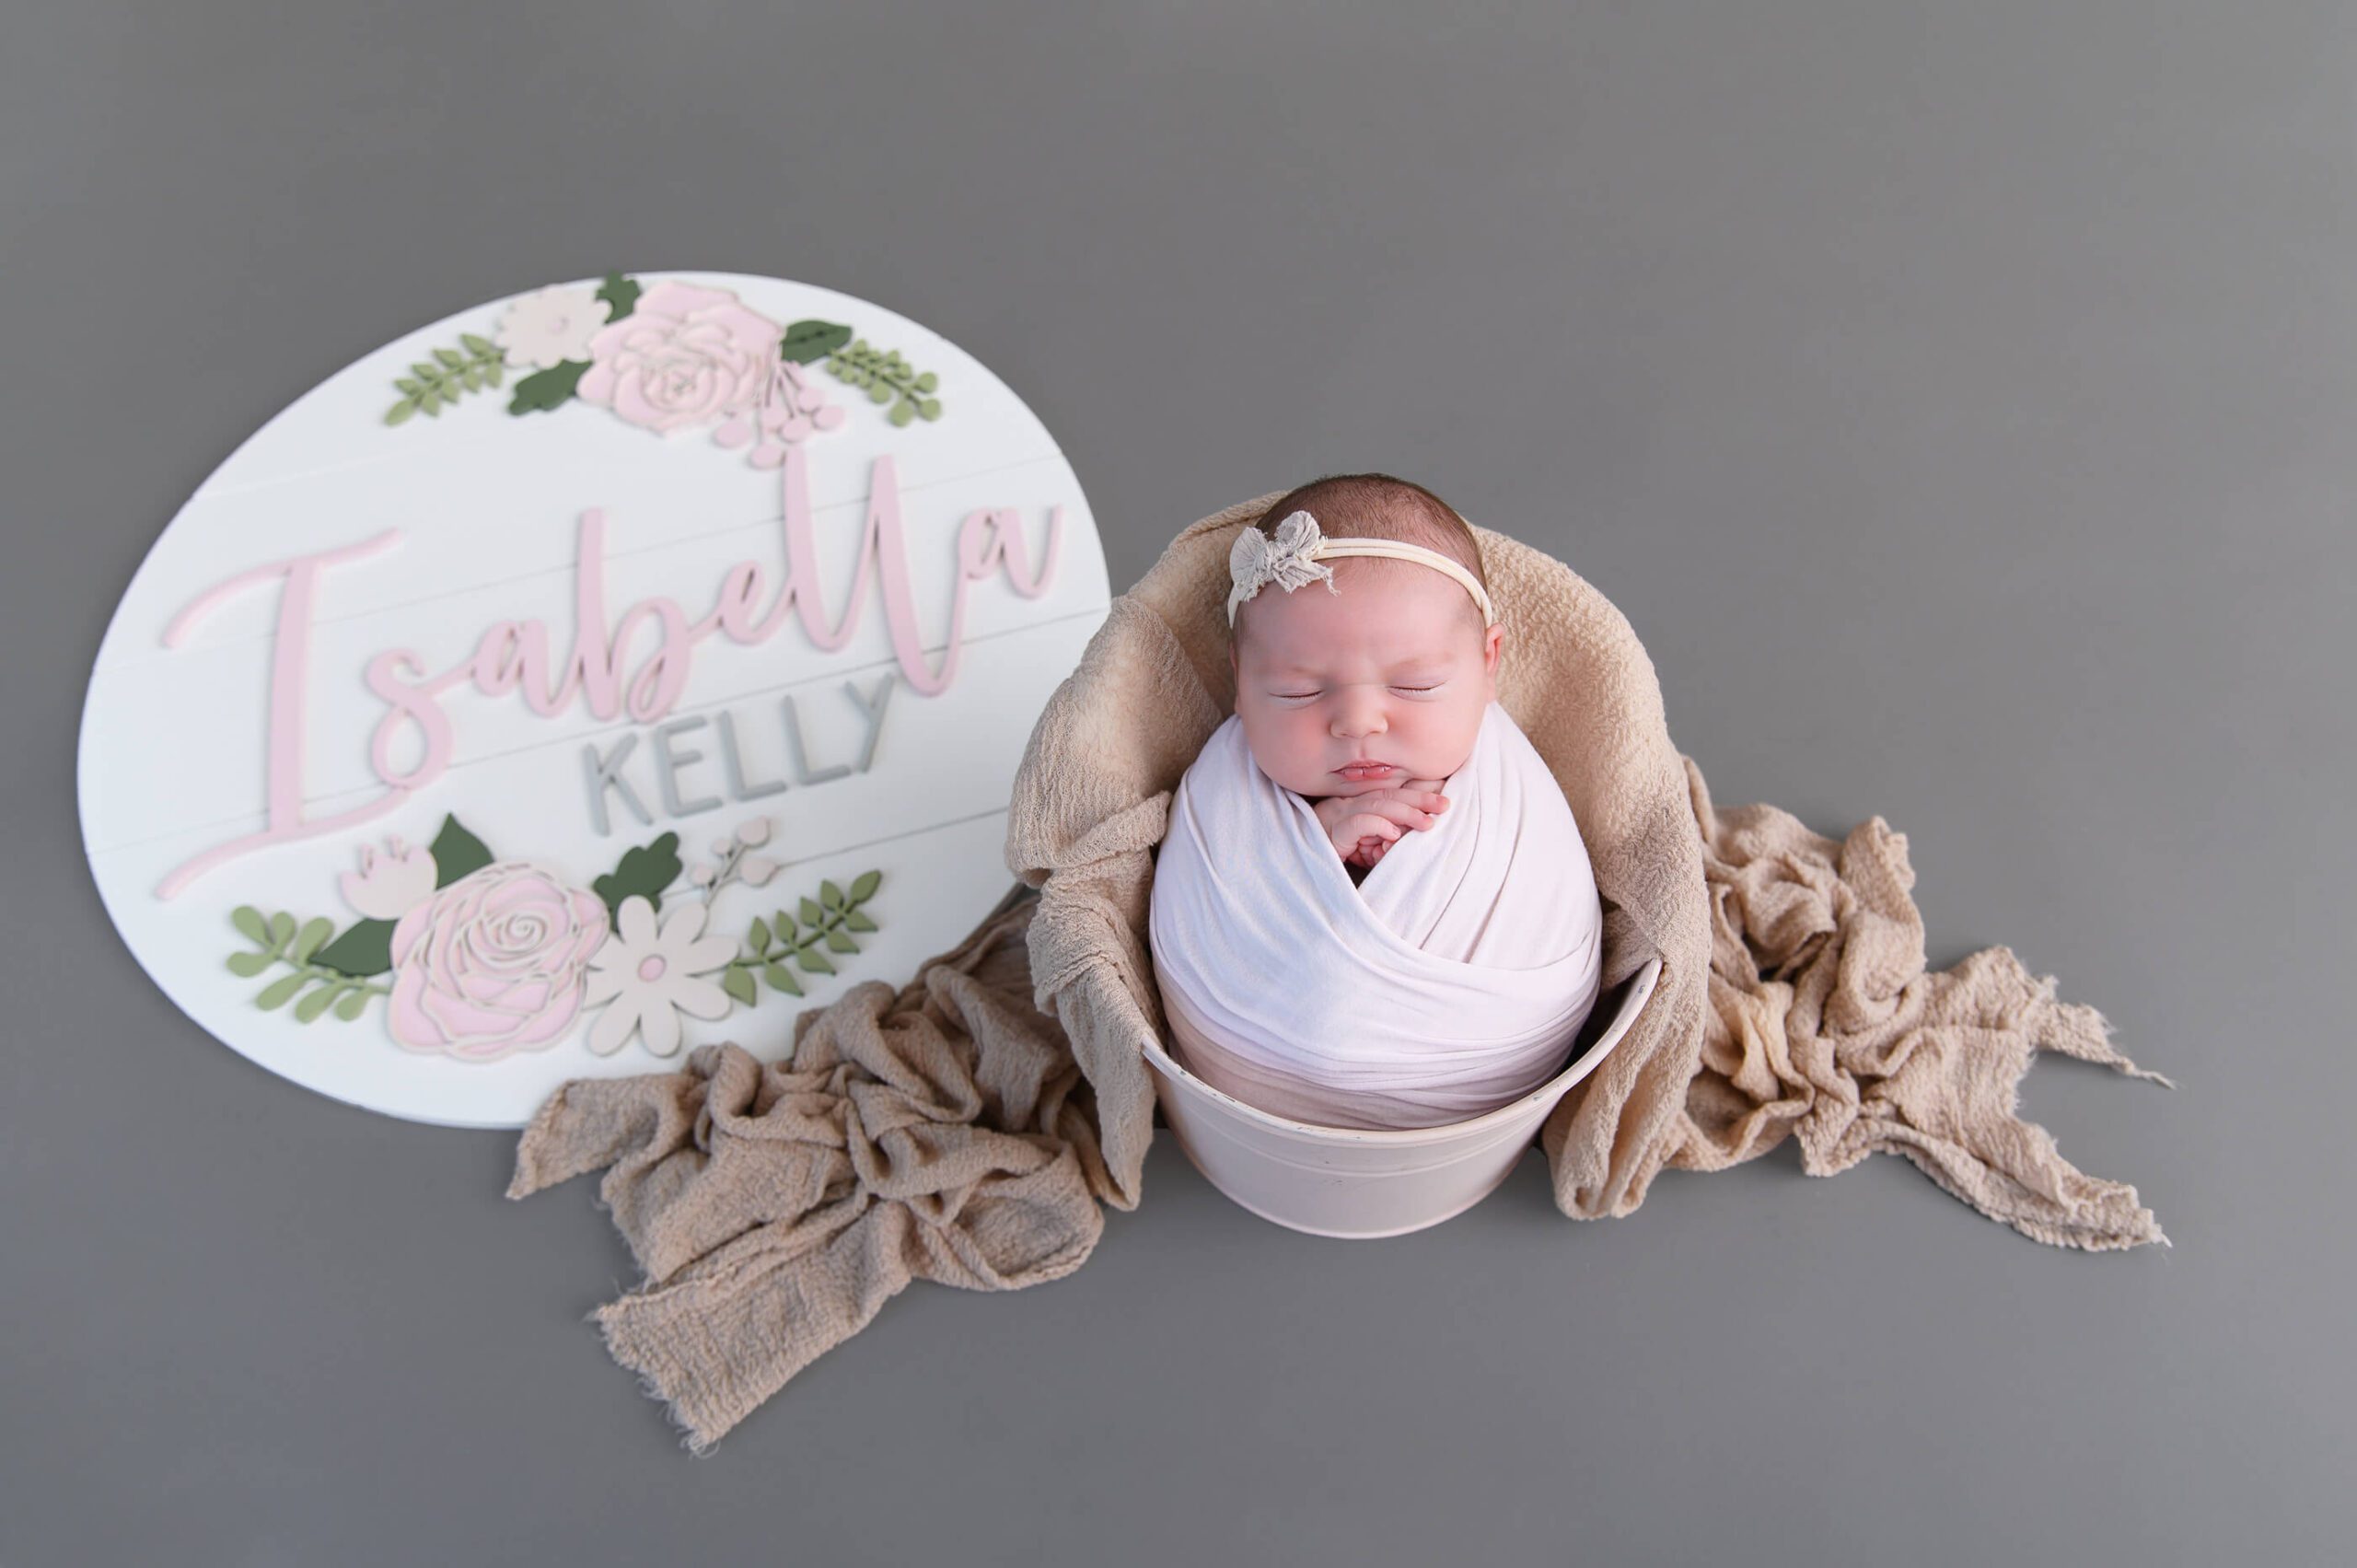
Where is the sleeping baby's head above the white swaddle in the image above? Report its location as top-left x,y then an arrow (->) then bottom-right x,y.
1228,474 -> 1504,799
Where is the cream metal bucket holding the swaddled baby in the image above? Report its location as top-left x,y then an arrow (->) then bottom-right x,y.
1145,958 -> 1662,1237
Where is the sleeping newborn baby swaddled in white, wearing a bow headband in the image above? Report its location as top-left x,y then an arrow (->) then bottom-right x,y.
1148,474 -> 1603,1127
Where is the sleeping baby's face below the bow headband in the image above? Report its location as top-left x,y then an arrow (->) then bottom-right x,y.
1228,556 -> 1504,799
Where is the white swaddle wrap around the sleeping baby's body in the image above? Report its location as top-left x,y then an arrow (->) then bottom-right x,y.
1148,703 -> 1603,1127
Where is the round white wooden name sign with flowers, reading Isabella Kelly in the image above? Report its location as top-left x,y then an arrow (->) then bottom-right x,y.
80,273 -> 1110,1127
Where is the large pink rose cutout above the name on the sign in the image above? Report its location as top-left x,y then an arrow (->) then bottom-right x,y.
577,281 -> 784,432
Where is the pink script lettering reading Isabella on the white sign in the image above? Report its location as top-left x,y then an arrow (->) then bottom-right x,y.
156,446 -> 1063,899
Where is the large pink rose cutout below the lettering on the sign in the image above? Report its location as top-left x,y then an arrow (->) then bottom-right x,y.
387,861 -> 606,1061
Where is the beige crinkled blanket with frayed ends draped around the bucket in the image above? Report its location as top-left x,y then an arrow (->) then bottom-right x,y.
509,493 -> 2168,1447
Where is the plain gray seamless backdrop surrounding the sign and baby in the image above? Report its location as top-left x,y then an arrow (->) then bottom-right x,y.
0,0 -> 2357,1568
